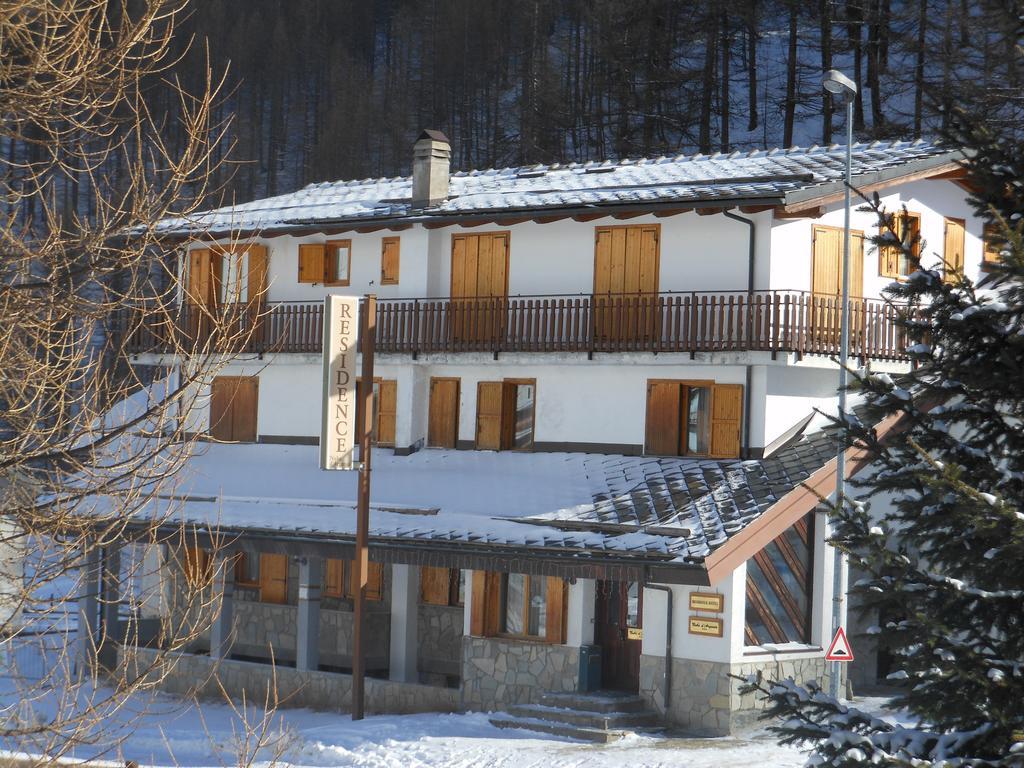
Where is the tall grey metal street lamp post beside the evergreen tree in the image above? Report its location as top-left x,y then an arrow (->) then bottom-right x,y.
821,70 -> 857,698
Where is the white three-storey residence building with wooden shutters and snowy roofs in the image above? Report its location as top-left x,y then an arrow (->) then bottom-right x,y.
97,131 -> 985,733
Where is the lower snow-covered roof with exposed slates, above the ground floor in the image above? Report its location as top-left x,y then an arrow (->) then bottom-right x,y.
105,409 -> 836,567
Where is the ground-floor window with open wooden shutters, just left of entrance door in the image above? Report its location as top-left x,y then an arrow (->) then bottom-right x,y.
470,570 -> 566,643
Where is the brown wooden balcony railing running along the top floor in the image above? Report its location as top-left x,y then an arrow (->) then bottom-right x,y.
111,291 -> 906,359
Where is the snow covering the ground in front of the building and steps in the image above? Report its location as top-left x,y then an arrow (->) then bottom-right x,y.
0,684 -> 806,768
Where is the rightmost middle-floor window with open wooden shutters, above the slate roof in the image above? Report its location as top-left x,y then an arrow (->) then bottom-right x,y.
644,379 -> 743,459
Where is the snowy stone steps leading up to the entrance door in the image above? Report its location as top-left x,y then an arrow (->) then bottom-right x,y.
490,691 -> 662,743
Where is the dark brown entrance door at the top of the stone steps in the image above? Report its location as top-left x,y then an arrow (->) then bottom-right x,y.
594,582 -> 643,693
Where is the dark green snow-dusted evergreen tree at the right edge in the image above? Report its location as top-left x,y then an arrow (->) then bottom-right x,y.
745,24 -> 1024,766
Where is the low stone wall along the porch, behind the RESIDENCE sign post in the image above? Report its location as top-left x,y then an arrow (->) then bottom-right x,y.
119,647 -> 459,715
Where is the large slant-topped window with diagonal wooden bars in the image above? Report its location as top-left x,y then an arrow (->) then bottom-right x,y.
745,514 -> 814,645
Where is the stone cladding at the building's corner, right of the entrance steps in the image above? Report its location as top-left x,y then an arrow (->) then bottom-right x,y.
640,654 -> 830,736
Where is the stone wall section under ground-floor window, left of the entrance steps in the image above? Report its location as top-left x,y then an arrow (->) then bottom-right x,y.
462,637 -> 580,710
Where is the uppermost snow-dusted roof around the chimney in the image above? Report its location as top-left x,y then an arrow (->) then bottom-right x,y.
160,140 -> 962,234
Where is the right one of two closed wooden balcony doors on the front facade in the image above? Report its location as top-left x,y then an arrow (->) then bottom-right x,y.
594,224 -> 659,340
